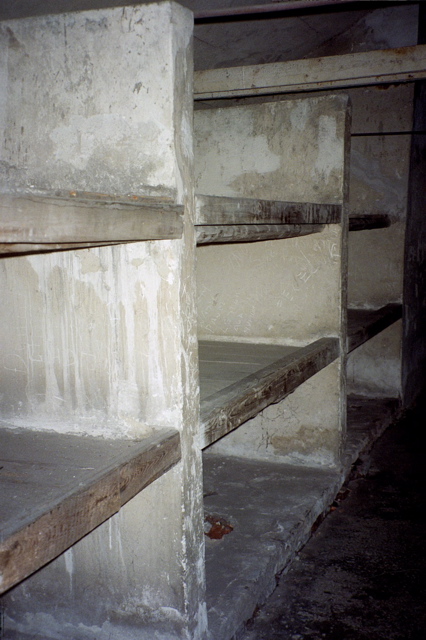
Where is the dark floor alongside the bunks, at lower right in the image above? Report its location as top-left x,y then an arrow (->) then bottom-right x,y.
237,403 -> 426,640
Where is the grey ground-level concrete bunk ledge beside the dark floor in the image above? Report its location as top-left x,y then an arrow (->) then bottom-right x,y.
204,397 -> 400,640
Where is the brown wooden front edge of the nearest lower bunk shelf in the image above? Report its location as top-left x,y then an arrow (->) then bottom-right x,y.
0,429 -> 181,594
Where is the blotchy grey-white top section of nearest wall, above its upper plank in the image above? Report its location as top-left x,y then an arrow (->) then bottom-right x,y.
0,2 -> 182,197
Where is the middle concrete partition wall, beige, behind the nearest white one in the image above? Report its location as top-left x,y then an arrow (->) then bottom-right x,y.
194,97 -> 349,465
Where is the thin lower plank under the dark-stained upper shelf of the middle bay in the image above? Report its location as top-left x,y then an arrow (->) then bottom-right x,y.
195,224 -> 324,245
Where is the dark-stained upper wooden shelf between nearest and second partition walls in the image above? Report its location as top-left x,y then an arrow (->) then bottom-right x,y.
195,195 -> 342,245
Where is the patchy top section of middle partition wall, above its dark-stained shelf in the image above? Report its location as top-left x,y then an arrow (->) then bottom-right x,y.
194,96 -> 347,203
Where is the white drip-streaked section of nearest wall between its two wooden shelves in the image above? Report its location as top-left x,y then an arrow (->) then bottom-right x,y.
1,240 -> 182,436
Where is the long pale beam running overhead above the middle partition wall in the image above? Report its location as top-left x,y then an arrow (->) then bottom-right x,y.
194,45 -> 426,100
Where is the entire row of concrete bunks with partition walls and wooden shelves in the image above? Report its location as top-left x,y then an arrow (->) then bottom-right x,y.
0,2 -> 424,640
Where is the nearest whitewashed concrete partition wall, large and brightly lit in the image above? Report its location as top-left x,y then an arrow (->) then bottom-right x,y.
0,2 -> 206,640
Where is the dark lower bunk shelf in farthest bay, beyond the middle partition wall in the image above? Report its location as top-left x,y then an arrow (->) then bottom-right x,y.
347,303 -> 402,352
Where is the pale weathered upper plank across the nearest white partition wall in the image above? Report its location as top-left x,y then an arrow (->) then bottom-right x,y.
0,192 -> 183,254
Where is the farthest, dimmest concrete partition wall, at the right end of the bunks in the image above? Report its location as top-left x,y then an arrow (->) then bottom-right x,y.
348,84 -> 413,397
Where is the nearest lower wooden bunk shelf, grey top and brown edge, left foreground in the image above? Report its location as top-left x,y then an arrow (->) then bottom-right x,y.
0,425 -> 180,593
